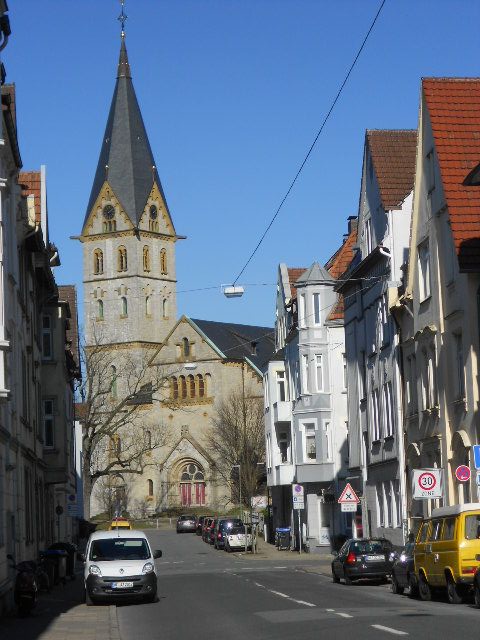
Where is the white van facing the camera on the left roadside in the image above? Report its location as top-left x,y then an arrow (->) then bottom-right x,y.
84,529 -> 162,605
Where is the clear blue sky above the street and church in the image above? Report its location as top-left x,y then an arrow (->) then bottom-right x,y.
2,0 -> 480,326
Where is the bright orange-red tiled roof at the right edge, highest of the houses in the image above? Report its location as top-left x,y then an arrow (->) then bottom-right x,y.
422,78 -> 480,271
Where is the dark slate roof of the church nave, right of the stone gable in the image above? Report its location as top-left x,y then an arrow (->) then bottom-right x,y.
190,318 -> 275,371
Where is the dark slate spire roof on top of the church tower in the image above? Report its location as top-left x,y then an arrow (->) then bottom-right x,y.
84,33 -> 171,227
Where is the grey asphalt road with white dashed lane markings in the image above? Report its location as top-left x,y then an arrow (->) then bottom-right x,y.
117,531 -> 480,640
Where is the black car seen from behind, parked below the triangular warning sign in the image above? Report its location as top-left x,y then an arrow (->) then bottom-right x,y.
332,538 -> 393,584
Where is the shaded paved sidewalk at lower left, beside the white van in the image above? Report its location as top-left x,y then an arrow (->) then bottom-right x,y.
0,575 -> 120,640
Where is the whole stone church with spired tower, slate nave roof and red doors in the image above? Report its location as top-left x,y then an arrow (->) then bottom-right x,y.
80,33 -> 274,515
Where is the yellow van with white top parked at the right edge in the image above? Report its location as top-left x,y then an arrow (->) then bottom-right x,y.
414,502 -> 480,604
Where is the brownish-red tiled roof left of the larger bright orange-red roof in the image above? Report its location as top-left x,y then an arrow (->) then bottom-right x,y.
366,129 -> 417,210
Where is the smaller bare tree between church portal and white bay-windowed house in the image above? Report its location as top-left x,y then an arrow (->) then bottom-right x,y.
207,389 -> 265,506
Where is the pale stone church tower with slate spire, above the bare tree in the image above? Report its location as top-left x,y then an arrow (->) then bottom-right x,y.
80,30 -> 180,349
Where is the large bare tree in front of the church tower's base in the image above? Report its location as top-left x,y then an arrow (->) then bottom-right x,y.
78,330 -> 175,519
